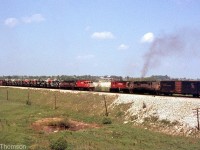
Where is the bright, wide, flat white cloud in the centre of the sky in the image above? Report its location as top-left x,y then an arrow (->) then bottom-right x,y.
91,31 -> 114,40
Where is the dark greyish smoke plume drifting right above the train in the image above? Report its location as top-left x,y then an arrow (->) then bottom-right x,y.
141,30 -> 200,77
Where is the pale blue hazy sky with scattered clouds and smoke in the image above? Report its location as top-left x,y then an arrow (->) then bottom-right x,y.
0,0 -> 200,78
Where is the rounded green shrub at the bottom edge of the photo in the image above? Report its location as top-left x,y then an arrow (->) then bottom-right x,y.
50,137 -> 68,150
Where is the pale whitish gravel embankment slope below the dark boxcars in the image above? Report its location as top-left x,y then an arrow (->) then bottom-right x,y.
110,94 -> 200,136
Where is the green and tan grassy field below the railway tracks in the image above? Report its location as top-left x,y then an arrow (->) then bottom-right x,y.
0,87 -> 200,150
